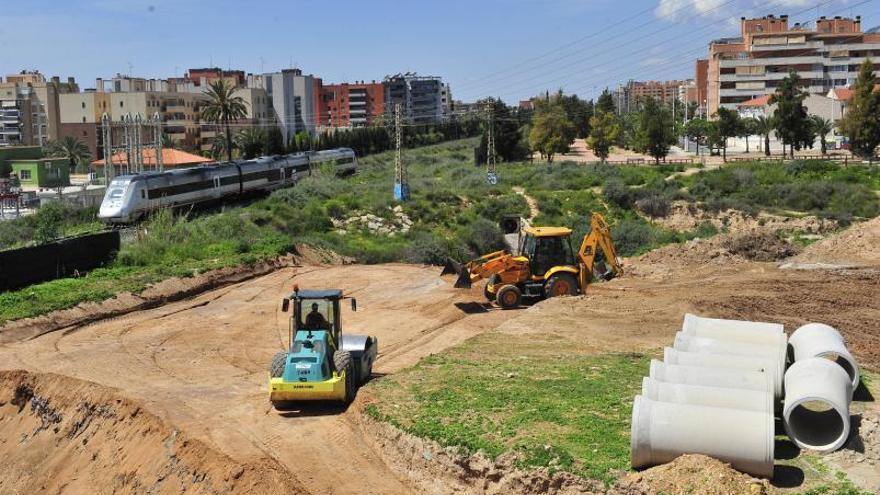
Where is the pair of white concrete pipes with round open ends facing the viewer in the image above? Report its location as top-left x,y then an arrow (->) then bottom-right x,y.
782,323 -> 859,452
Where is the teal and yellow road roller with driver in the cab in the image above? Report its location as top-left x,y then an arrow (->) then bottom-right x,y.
269,286 -> 379,408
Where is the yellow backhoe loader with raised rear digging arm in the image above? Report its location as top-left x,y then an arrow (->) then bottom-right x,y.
443,213 -> 623,309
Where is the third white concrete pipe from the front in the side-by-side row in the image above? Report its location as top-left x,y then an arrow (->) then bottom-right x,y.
649,359 -> 775,395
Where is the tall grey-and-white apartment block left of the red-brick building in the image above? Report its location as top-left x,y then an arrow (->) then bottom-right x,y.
247,69 -> 322,141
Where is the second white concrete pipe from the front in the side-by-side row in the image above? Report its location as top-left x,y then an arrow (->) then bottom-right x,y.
642,376 -> 775,414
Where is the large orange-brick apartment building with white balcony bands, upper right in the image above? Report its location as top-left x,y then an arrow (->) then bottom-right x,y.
697,15 -> 880,115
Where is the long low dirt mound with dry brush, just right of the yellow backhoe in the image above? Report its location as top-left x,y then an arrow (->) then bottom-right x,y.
626,230 -> 798,277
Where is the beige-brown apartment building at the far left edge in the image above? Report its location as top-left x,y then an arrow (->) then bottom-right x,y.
0,71 -> 79,146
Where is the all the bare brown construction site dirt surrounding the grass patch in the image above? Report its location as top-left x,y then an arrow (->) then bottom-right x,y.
0,220 -> 880,494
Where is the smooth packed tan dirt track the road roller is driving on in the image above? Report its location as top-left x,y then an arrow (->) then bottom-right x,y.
0,265 -> 504,494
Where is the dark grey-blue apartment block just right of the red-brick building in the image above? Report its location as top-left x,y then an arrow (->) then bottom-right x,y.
383,72 -> 452,124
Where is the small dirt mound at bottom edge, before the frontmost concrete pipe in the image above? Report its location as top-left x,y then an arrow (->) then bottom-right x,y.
620,455 -> 769,495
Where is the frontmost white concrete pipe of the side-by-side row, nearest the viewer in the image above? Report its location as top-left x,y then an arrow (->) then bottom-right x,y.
630,395 -> 774,478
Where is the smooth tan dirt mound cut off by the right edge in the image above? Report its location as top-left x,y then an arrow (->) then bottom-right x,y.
795,217 -> 880,266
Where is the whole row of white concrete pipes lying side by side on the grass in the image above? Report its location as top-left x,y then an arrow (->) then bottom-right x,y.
630,315 -> 787,477
